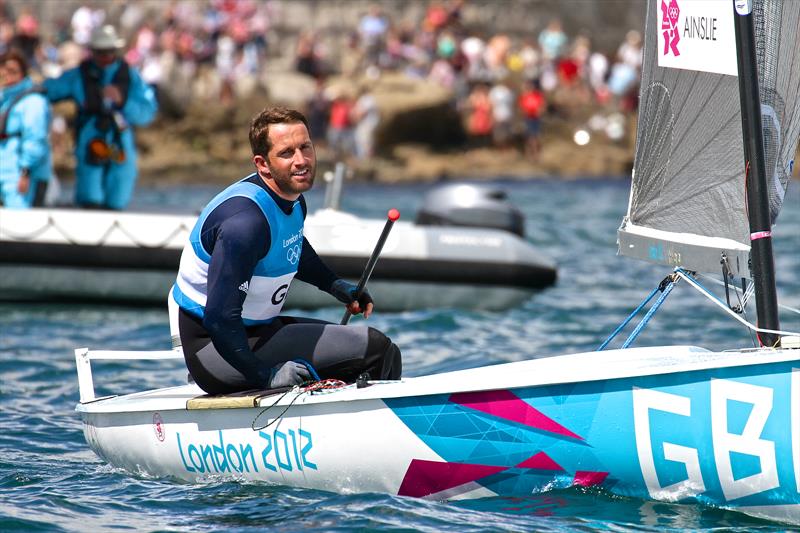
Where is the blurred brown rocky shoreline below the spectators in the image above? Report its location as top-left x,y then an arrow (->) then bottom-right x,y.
55,79 -> 635,185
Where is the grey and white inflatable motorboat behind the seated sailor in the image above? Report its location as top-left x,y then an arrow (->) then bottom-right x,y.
0,184 -> 556,310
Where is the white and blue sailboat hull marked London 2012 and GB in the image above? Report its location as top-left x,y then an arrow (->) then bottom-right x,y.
78,347 -> 800,524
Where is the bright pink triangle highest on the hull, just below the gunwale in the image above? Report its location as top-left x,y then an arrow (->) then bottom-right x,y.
449,390 -> 583,440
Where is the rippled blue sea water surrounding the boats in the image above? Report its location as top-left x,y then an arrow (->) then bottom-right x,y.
0,180 -> 800,532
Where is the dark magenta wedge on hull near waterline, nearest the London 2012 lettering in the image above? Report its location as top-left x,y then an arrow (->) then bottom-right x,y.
397,459 -> 507,498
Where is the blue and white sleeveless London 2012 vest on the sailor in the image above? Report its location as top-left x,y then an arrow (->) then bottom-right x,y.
172,181 -> 303,326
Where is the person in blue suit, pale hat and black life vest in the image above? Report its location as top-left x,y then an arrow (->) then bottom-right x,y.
44,25 -> 158,209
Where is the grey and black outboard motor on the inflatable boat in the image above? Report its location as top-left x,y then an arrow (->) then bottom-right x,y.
416,184 -> 525,237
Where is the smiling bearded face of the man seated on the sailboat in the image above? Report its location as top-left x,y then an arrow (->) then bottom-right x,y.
253,122 -> 317,200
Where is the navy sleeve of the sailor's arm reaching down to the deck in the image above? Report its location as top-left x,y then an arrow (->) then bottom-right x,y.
202,198 -> 270,386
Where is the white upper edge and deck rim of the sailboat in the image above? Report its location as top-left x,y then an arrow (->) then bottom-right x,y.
75,345 -> 800,415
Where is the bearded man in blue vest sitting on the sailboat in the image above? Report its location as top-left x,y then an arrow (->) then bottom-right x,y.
170,107 -> 401,394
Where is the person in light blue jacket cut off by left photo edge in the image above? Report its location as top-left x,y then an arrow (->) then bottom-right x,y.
0,49 -> 53,208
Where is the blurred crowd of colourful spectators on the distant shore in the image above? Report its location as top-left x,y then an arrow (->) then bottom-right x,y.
0,0 -> 642,166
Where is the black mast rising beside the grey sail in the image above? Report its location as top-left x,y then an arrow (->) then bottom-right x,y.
734,0 -> 780,346
